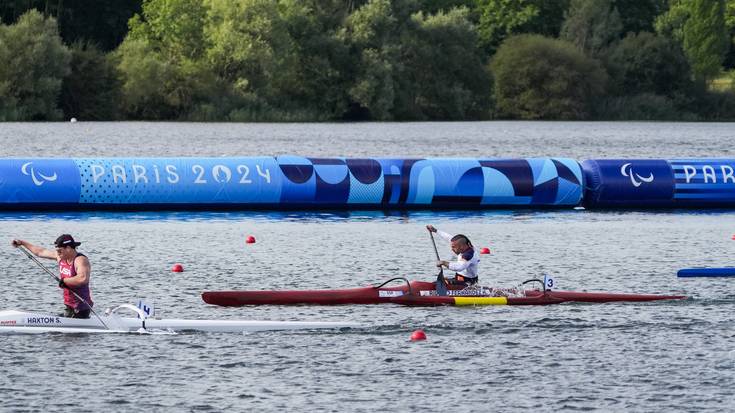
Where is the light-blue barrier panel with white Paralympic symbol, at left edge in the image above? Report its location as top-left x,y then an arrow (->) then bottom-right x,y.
0,158 -> 80,203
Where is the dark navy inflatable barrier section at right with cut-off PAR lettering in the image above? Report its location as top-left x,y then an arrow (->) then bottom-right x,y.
582,159 -> 735,208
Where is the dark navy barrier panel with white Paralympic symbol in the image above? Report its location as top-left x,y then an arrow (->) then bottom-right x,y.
582,159 -> 674,208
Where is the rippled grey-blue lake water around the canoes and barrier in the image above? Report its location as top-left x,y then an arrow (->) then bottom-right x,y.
0,122 -> 735,412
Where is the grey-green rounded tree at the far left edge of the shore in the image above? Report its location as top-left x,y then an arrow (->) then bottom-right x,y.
0,10 -> 70,120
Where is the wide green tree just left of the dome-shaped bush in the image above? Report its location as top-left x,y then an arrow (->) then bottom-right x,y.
340,0 -> 492,120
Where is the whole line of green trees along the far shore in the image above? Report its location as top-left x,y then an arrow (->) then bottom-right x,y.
0,0 -> 735,121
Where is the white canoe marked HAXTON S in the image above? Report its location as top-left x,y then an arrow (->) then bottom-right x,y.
0,304 -> 360,333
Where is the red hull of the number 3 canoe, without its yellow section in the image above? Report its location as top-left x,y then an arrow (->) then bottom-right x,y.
202,281 -> 686,307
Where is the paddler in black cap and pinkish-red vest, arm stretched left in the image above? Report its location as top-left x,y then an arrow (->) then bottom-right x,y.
11,234 -> 94,318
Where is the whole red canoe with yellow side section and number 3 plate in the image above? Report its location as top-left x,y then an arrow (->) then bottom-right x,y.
202,278 -> 686,307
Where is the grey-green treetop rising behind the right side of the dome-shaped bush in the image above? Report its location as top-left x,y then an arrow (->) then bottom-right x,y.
560,0 -> 623,56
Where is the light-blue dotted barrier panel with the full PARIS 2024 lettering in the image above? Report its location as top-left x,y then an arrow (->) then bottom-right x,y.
75,157 -> 282,206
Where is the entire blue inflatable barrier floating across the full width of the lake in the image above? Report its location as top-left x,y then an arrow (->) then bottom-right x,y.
0,156 -> 735,210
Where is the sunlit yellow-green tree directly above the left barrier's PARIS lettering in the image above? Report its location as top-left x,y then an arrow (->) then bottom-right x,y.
114,0 -> 217,119
